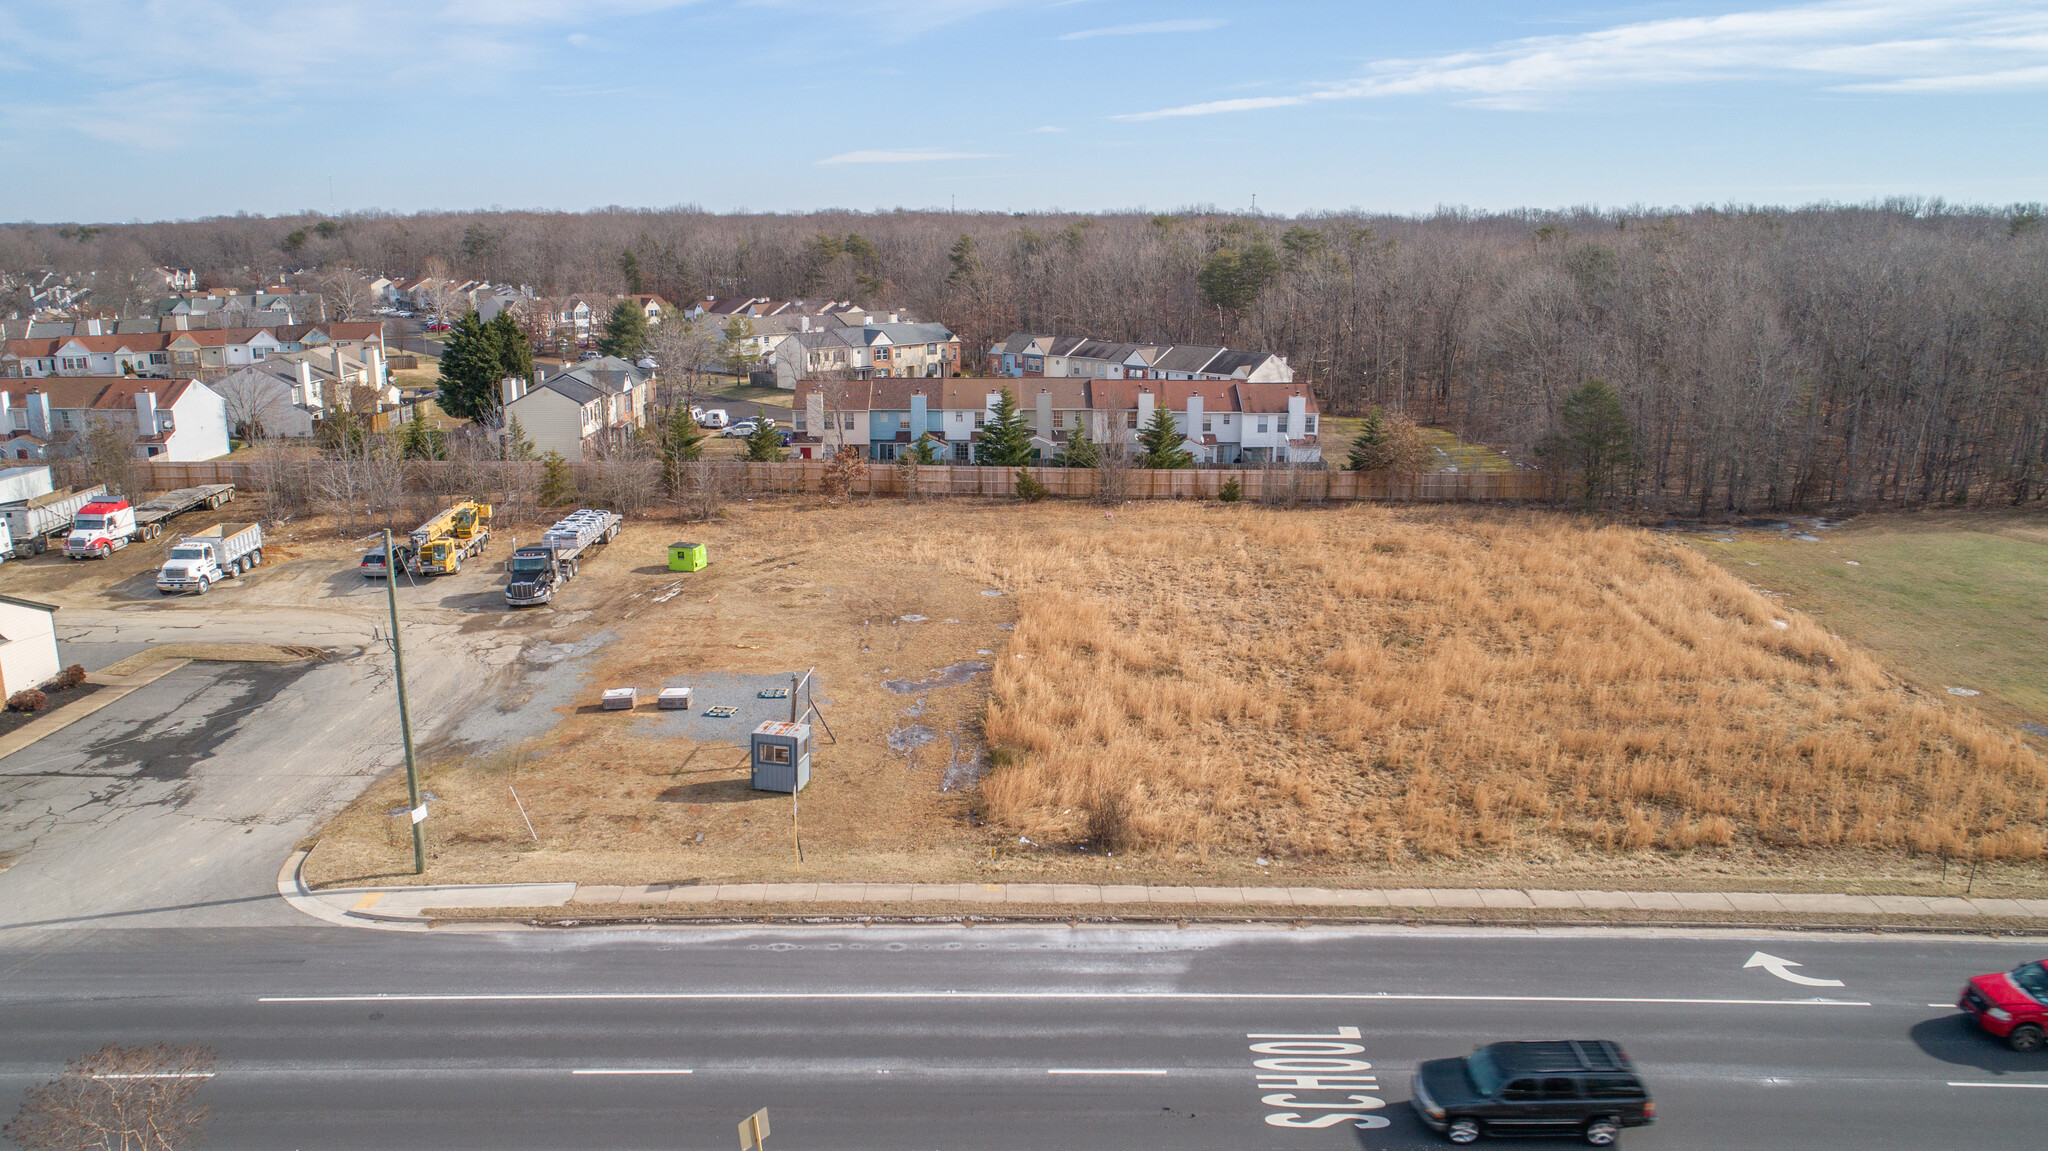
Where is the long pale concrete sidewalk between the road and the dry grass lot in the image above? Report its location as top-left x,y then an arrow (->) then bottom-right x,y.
279,852 -> 2048,930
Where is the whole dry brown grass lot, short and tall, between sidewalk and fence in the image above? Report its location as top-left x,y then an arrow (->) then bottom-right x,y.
313,502 -> 2048,893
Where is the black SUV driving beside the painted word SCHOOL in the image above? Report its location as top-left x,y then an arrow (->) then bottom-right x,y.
1413,1038 -> 1657,1147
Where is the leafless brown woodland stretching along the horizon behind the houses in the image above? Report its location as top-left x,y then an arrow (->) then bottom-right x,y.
0,201 -> 2048,514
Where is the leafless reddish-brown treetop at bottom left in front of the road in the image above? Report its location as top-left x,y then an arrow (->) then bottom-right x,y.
0,1042 -> 215,1151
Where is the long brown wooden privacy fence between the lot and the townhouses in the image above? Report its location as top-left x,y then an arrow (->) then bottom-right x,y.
145,459 -> 1571,504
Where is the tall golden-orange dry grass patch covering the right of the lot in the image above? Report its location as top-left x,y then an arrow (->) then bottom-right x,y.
933,504 -> 2048,864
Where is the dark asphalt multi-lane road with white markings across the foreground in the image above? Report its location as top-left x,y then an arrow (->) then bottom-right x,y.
0,928 -> 2048,1151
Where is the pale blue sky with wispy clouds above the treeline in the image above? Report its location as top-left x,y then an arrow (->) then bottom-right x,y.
0,0 -> 2048,221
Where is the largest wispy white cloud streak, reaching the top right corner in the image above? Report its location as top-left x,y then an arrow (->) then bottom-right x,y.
1112,0 -> 2048,121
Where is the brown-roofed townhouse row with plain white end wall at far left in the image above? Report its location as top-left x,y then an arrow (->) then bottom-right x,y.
0,375 -> 229,463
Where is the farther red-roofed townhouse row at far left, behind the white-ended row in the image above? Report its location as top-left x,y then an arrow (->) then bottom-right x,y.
0,317 -> 385,379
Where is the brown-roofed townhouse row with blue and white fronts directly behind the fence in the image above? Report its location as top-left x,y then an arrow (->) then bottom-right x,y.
791,377 -> 1323,463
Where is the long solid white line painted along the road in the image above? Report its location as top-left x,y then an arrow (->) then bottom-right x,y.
256,991 -> 1870,1008
